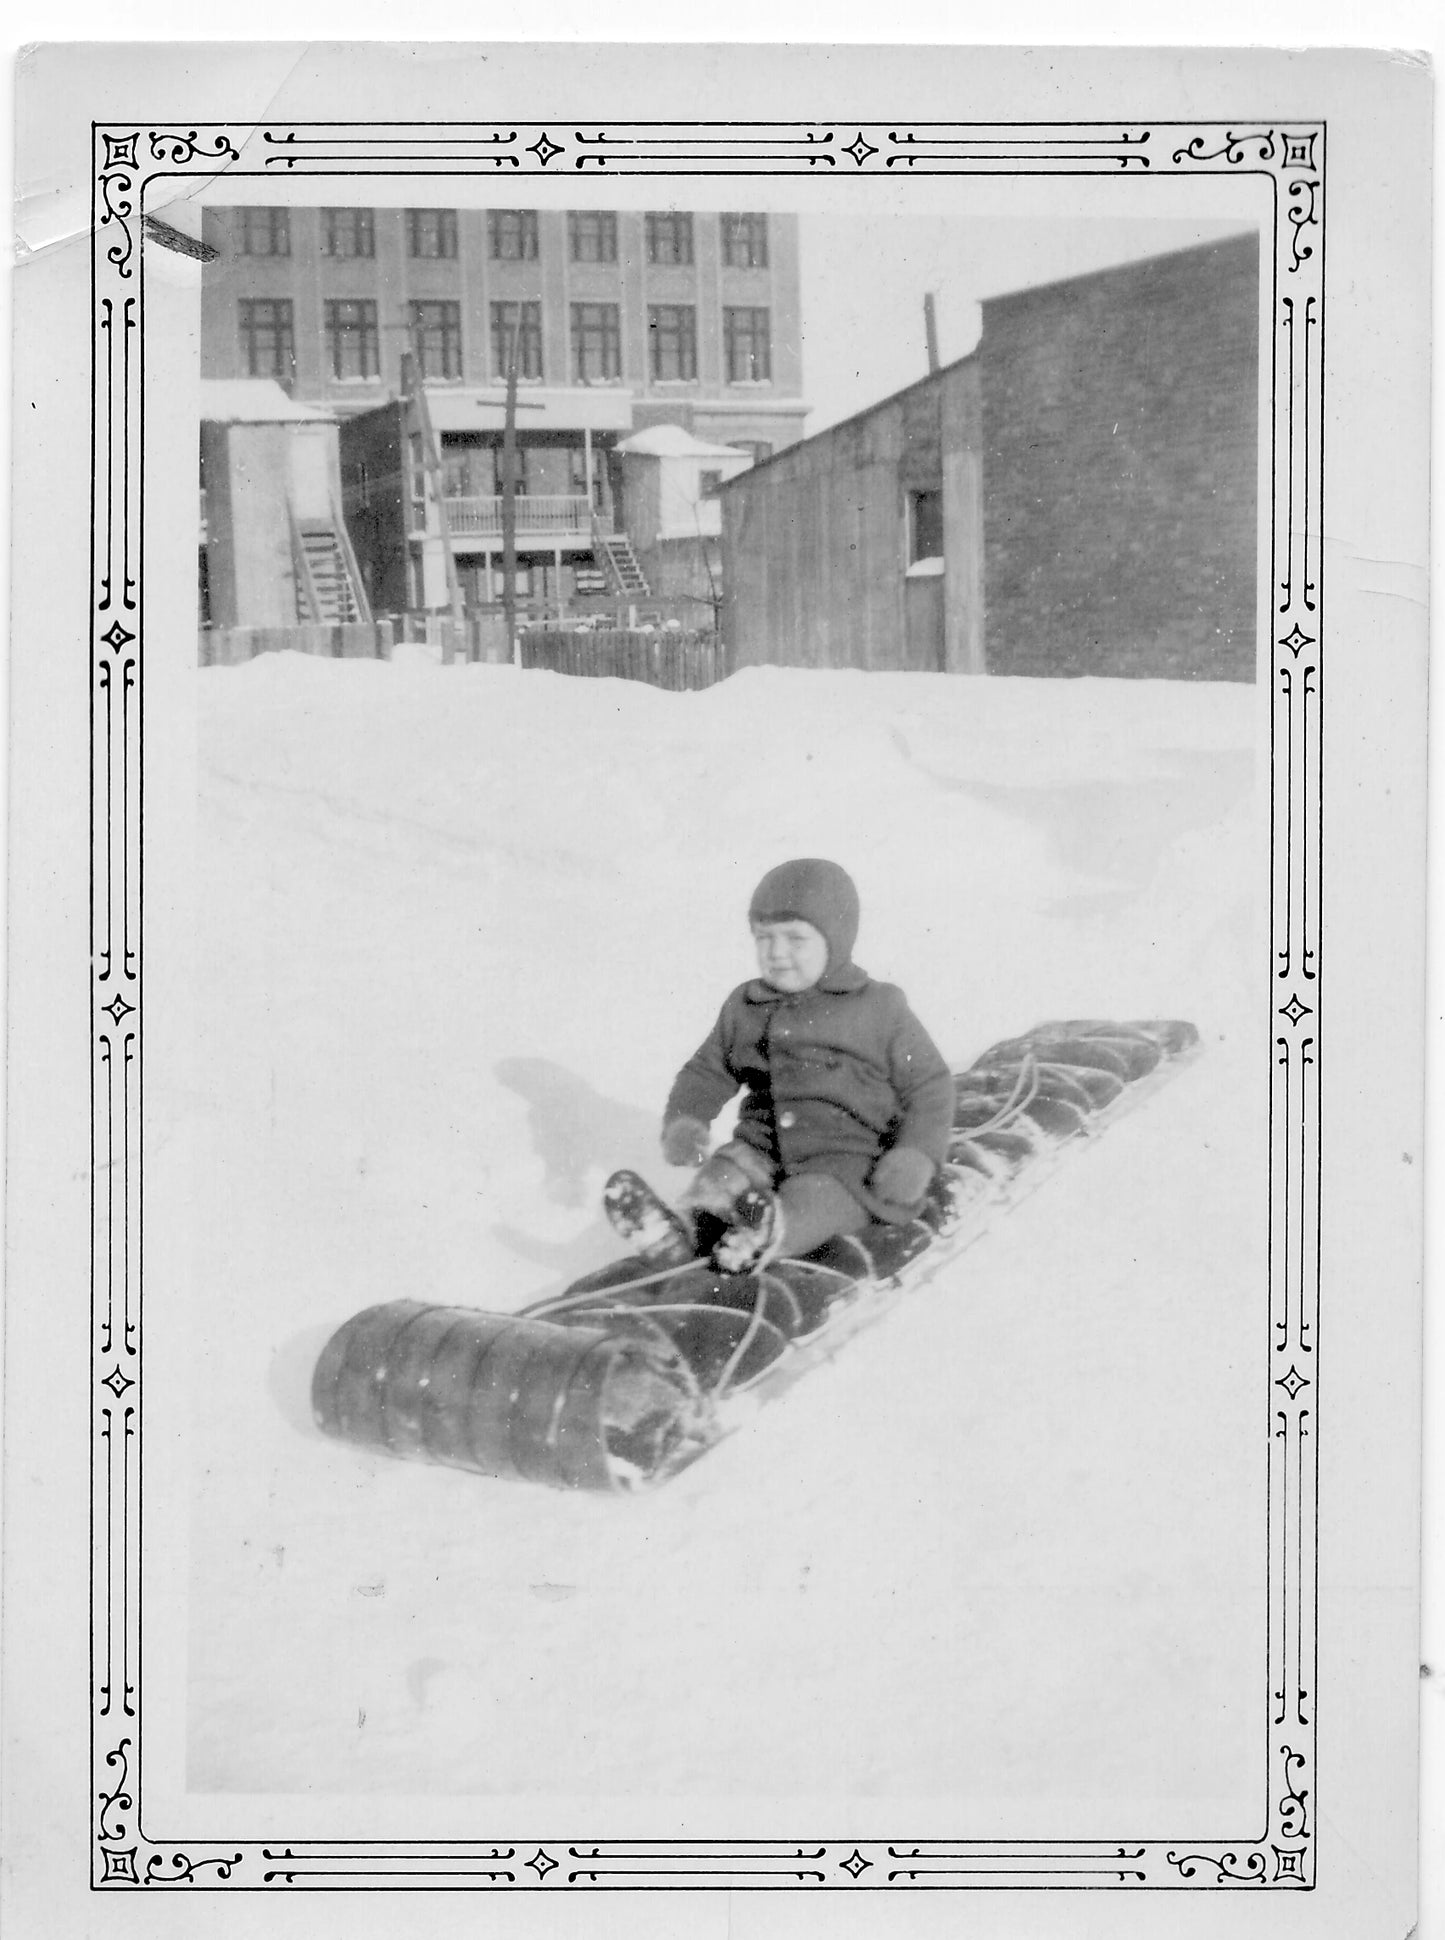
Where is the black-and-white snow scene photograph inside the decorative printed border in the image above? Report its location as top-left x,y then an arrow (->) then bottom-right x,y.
188,178 -> 1284,1837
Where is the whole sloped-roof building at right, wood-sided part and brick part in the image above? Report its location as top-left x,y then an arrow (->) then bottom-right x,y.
720,235 -> 1259,681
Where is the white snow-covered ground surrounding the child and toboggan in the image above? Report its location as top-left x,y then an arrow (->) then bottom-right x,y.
186,656 -> 1268,1837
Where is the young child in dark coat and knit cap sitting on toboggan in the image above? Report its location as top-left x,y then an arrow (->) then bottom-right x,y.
661,857 -> 954,1273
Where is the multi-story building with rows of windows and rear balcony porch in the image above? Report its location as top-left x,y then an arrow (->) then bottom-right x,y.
202,206 -> 807,603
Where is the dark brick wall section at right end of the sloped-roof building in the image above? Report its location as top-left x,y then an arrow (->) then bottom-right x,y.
979,235 -> 1259,681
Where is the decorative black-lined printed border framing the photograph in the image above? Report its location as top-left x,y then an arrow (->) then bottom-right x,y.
89,122 -> 1325,1892
